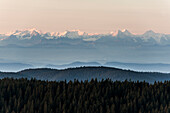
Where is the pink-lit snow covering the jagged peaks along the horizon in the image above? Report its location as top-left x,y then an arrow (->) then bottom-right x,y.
1,28 -> 170,43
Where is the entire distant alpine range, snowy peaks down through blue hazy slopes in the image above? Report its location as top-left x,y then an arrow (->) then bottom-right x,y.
0,28 -> 170,65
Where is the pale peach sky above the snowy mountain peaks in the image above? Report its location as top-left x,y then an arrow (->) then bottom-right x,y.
0,0 -> 170,34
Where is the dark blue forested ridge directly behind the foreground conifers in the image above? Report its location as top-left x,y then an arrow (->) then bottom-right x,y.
0,67 -> 170,83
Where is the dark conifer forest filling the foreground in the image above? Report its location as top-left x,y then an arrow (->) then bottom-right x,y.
0,78 -> 170,113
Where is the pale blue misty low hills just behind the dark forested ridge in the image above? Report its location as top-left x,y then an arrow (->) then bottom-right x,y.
0,60 -> 170,73
